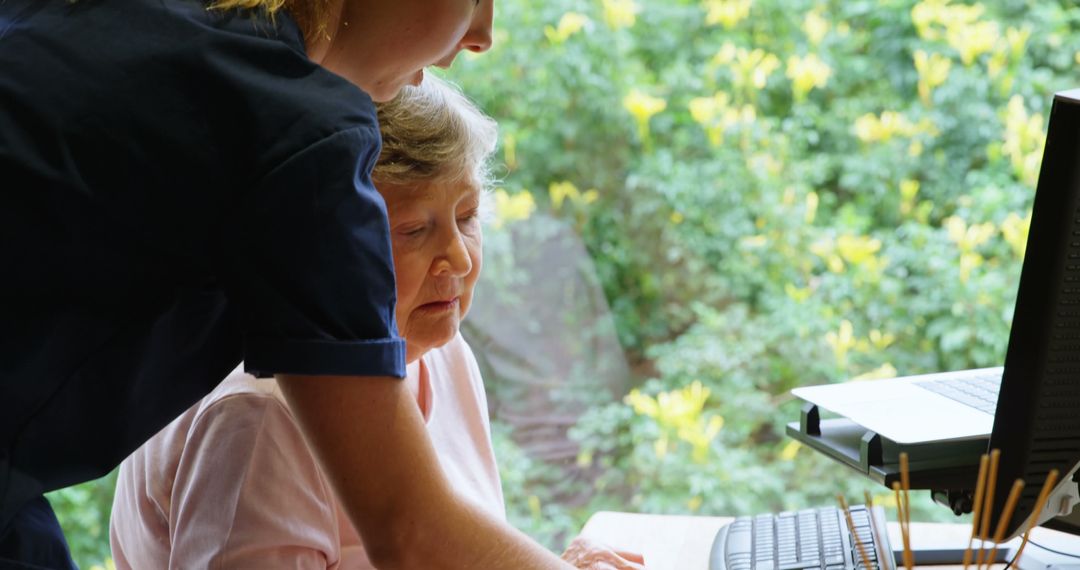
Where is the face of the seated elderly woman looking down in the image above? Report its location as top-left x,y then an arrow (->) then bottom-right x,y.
376,182 -> 483,362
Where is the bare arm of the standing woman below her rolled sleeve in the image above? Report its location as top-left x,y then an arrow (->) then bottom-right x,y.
278,375 -> 569,569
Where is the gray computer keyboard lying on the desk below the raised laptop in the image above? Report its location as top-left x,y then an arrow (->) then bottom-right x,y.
708,505 -> 895,570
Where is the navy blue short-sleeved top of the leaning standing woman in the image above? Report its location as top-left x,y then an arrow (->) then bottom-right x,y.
0,0 -> 405,529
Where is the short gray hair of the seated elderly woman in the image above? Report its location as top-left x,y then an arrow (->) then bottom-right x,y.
372,73 -> 498,189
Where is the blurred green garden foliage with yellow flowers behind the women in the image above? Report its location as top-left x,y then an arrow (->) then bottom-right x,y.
49,0 -> 1080,568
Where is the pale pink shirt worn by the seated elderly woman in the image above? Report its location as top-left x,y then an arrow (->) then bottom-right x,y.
110,335 -> 505,570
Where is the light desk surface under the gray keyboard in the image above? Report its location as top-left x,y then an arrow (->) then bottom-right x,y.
581,512 -> 1080,570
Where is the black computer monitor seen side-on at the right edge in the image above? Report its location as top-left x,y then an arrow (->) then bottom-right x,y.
989,89 -> 1080,535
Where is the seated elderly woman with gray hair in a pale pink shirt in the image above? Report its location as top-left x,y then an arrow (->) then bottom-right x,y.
111,77 -> 640,569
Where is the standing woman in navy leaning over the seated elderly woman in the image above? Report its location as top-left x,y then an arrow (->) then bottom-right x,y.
0,0 -> 574,568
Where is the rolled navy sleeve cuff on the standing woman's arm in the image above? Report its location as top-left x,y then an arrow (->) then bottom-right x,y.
244,338 -> 405,378
